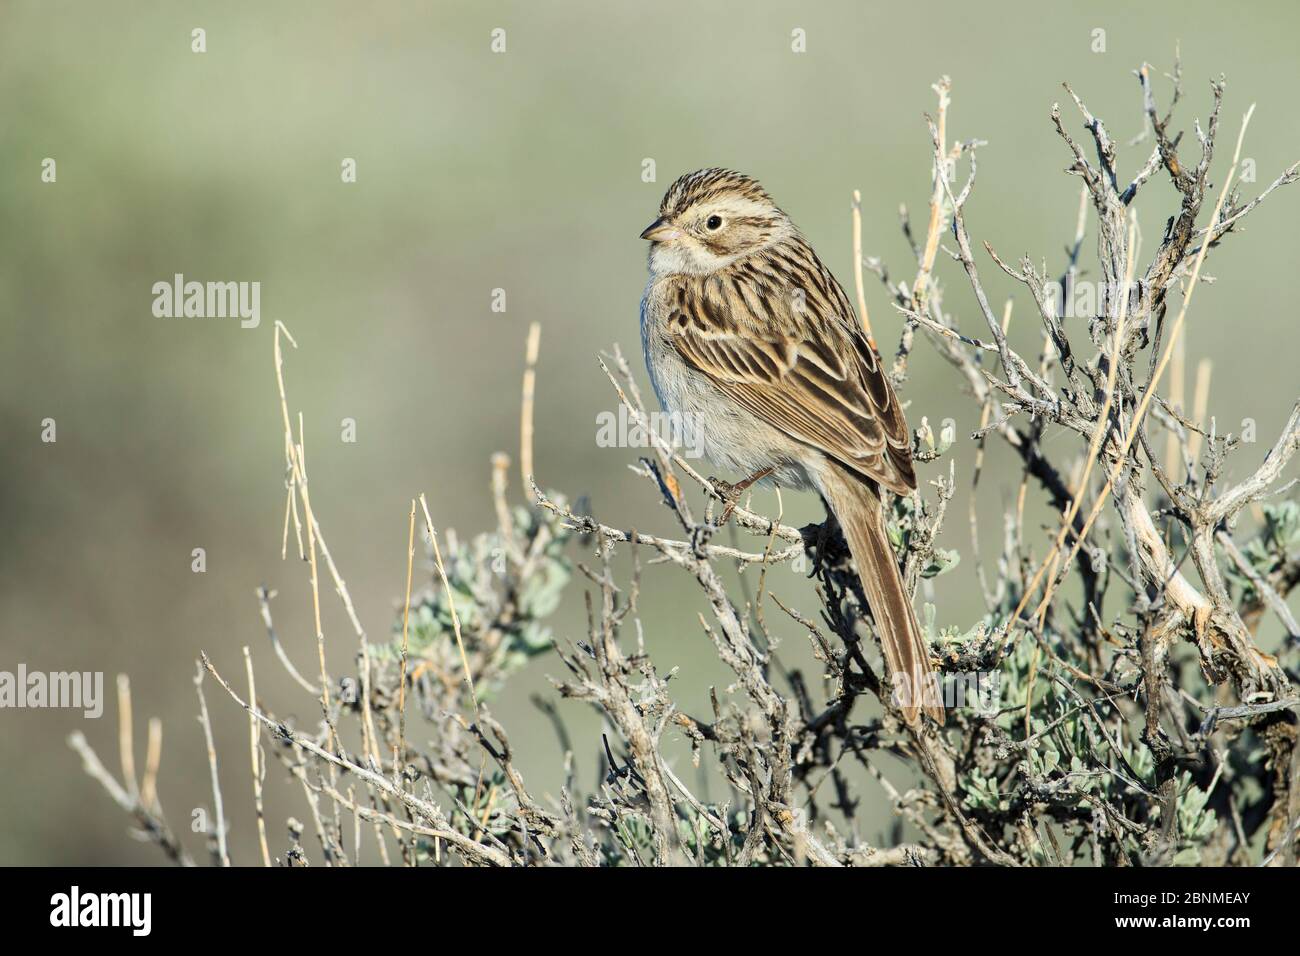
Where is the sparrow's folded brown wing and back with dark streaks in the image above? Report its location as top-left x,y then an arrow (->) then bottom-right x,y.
667,271 -> 917,494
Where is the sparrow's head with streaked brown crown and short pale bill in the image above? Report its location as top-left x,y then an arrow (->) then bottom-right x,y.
641,169 -> 794,276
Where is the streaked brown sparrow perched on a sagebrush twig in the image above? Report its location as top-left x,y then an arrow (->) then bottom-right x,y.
641,169 -> 944,726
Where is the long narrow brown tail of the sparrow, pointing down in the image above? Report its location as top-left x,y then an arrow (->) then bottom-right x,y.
816,462 -> 944,727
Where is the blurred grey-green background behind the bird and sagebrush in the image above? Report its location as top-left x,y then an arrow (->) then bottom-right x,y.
0,0 -> 1300,864
